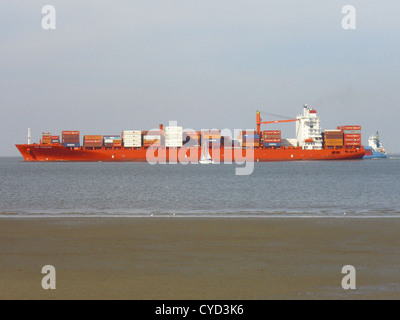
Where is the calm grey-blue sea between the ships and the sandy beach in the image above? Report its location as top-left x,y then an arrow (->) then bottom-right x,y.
0,156 -> 400,217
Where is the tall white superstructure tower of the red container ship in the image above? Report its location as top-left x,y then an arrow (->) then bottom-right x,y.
296,104 -> 322,150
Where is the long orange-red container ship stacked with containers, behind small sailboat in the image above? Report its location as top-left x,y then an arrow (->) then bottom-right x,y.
16,105 -> 365,163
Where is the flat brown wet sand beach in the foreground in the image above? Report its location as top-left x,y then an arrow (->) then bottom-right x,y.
0,217 -> 400,300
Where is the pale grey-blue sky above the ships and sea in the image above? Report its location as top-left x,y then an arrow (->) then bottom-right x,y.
0,0 -> 400,156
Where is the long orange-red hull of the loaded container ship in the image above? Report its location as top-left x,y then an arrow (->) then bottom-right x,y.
16,144 -> 365,163
